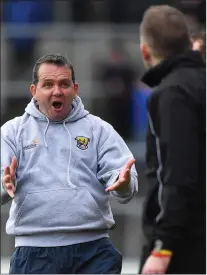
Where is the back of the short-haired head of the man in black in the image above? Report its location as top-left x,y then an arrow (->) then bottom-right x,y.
140,5 -> 191,68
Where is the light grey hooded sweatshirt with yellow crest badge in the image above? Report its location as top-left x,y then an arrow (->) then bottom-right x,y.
1,97 -> 138,247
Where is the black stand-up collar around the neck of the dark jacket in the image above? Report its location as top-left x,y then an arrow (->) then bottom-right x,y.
142,50 -> 205,87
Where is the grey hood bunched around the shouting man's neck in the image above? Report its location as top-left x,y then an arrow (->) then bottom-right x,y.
25,96 -> 89,123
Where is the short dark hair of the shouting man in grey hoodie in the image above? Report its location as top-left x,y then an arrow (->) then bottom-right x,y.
32,54 -> 75,85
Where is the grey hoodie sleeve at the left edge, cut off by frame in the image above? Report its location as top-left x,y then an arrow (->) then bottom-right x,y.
1,122 -> 17,205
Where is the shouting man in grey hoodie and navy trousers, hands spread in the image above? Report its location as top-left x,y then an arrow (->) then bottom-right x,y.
1,55 -> 138,274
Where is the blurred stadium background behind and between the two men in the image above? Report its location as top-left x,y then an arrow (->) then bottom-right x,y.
0,0 -> 206,274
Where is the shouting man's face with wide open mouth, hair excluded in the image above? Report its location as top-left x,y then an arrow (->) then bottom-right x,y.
30,63 -> 78,121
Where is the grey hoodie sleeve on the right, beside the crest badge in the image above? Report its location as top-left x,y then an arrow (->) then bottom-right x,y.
97,119 -> 138,203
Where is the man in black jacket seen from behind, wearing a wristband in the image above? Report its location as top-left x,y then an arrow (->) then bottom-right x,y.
137,5 -> 206,274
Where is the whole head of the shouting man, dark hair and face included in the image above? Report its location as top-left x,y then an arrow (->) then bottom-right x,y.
30,54 -> 78,121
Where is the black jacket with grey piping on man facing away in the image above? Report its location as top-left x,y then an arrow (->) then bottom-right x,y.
142,51 -> 206,253
